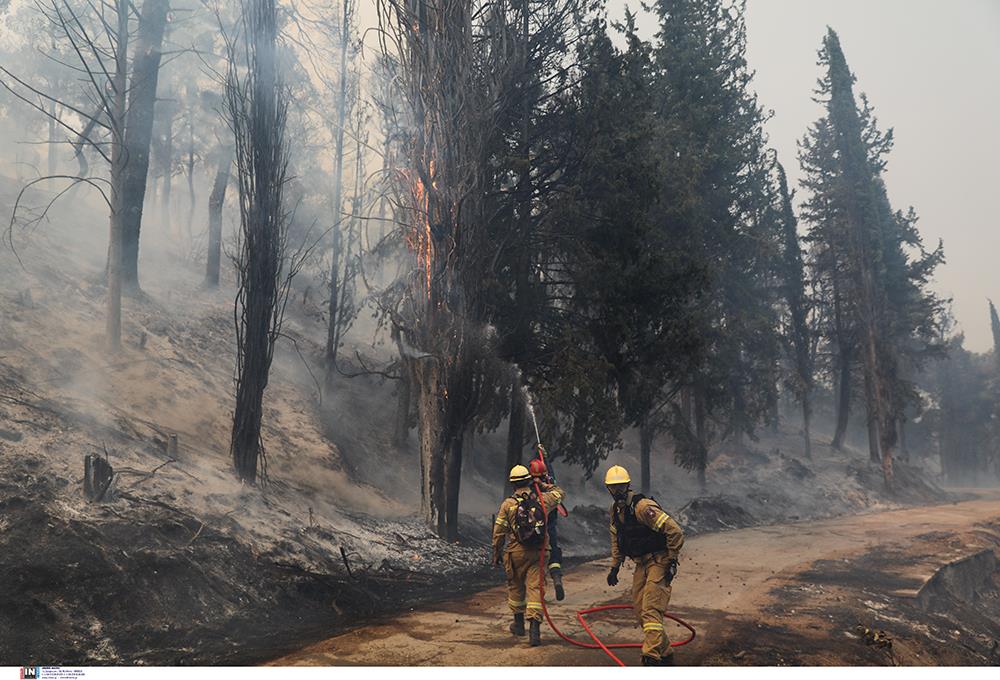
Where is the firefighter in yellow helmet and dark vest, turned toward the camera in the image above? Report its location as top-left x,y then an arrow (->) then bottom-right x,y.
604,465 -> 684,666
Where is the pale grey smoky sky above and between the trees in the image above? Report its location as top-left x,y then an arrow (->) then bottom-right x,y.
609,0 -> 1000,351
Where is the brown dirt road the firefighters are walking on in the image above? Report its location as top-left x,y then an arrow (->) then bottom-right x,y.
272,493 -> 1000,665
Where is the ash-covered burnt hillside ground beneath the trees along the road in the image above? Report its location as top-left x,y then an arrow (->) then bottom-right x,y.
0,184 -> 947,665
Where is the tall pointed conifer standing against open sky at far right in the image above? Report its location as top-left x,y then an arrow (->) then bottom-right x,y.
800,29 -> 944,489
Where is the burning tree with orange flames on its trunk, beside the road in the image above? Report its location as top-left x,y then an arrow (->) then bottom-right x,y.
379,0 -> 509,537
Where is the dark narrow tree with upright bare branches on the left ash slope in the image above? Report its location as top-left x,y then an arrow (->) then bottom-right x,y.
226,0 -> 291,484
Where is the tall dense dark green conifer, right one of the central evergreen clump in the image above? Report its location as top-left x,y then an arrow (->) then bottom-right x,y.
655,0 -> 780,484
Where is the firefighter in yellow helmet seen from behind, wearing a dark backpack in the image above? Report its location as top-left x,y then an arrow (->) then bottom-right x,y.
493,465 -> 565,647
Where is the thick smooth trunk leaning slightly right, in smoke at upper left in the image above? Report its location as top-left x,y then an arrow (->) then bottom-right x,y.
121,0 -> 170,291
